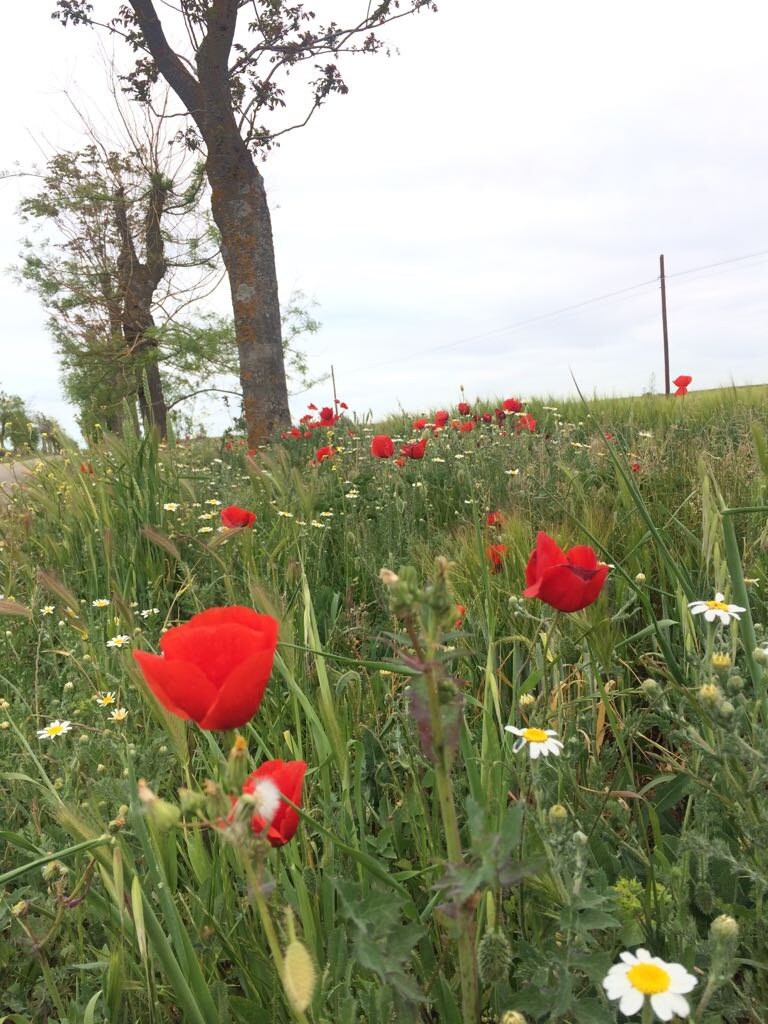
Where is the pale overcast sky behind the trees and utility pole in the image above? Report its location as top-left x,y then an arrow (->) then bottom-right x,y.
0,0 -> 768,428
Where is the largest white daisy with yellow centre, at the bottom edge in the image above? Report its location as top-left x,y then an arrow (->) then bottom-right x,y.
603,949 -> 698,1021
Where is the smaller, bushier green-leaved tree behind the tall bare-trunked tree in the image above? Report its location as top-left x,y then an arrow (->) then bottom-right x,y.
19,125 -> 218,436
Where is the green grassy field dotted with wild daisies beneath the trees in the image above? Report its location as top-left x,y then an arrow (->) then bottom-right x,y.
0,387 -> 768,1024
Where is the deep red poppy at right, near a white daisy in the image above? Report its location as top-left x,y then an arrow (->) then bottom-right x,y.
522,532 -> 610,611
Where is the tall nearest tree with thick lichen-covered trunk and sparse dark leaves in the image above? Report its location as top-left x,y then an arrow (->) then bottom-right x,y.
53,0 -> 435,445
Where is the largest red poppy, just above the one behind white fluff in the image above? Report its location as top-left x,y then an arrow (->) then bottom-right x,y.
133,605 -> 278,729
